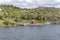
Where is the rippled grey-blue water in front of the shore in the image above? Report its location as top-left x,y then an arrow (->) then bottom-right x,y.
0,24 -> 60,40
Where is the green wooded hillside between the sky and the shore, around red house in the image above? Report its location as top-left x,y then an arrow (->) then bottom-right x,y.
0,5 -> 60,26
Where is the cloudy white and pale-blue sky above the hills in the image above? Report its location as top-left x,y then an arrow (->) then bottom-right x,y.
0,0 -> 60,8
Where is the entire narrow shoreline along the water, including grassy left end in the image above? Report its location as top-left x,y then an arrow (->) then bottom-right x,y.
0,22 -> 60,27
